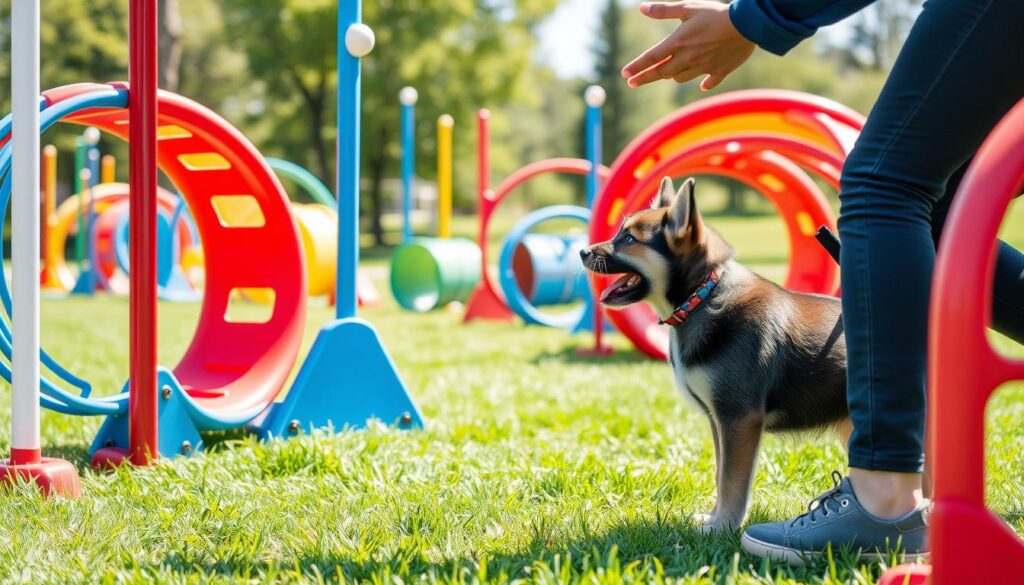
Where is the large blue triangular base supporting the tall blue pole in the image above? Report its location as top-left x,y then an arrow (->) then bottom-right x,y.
252,319 -> 423,438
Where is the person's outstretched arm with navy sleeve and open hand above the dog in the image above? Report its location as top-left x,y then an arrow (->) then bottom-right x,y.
623,0 -> 873,90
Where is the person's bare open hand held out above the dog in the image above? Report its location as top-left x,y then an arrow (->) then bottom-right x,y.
623,0 -> 755,91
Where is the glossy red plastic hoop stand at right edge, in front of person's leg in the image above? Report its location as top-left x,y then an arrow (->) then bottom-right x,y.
879,101 -> 1024,585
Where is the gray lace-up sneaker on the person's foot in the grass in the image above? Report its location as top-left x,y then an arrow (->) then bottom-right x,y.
740,471 -> 930,565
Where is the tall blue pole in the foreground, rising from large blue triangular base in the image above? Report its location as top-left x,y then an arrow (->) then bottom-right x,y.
336,0 -> 362,319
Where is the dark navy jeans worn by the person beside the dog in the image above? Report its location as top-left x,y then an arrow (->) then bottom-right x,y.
839,0 -> 1024,472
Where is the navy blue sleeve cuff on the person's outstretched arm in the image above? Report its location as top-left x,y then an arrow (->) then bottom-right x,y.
729,0 -> 874,55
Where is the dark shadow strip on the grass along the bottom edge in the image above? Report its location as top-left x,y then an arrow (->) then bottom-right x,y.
132,518 -> 897,583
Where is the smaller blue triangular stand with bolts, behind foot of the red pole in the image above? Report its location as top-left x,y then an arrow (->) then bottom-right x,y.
89,368 -> 203,457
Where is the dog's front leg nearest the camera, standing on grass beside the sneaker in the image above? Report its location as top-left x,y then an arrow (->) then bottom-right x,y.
707,413 -> 764,531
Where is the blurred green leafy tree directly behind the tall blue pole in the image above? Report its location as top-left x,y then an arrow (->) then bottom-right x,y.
222,0 -> 556,242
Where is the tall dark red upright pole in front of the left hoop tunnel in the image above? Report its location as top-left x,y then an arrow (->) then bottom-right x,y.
128,0 -> 159,465
